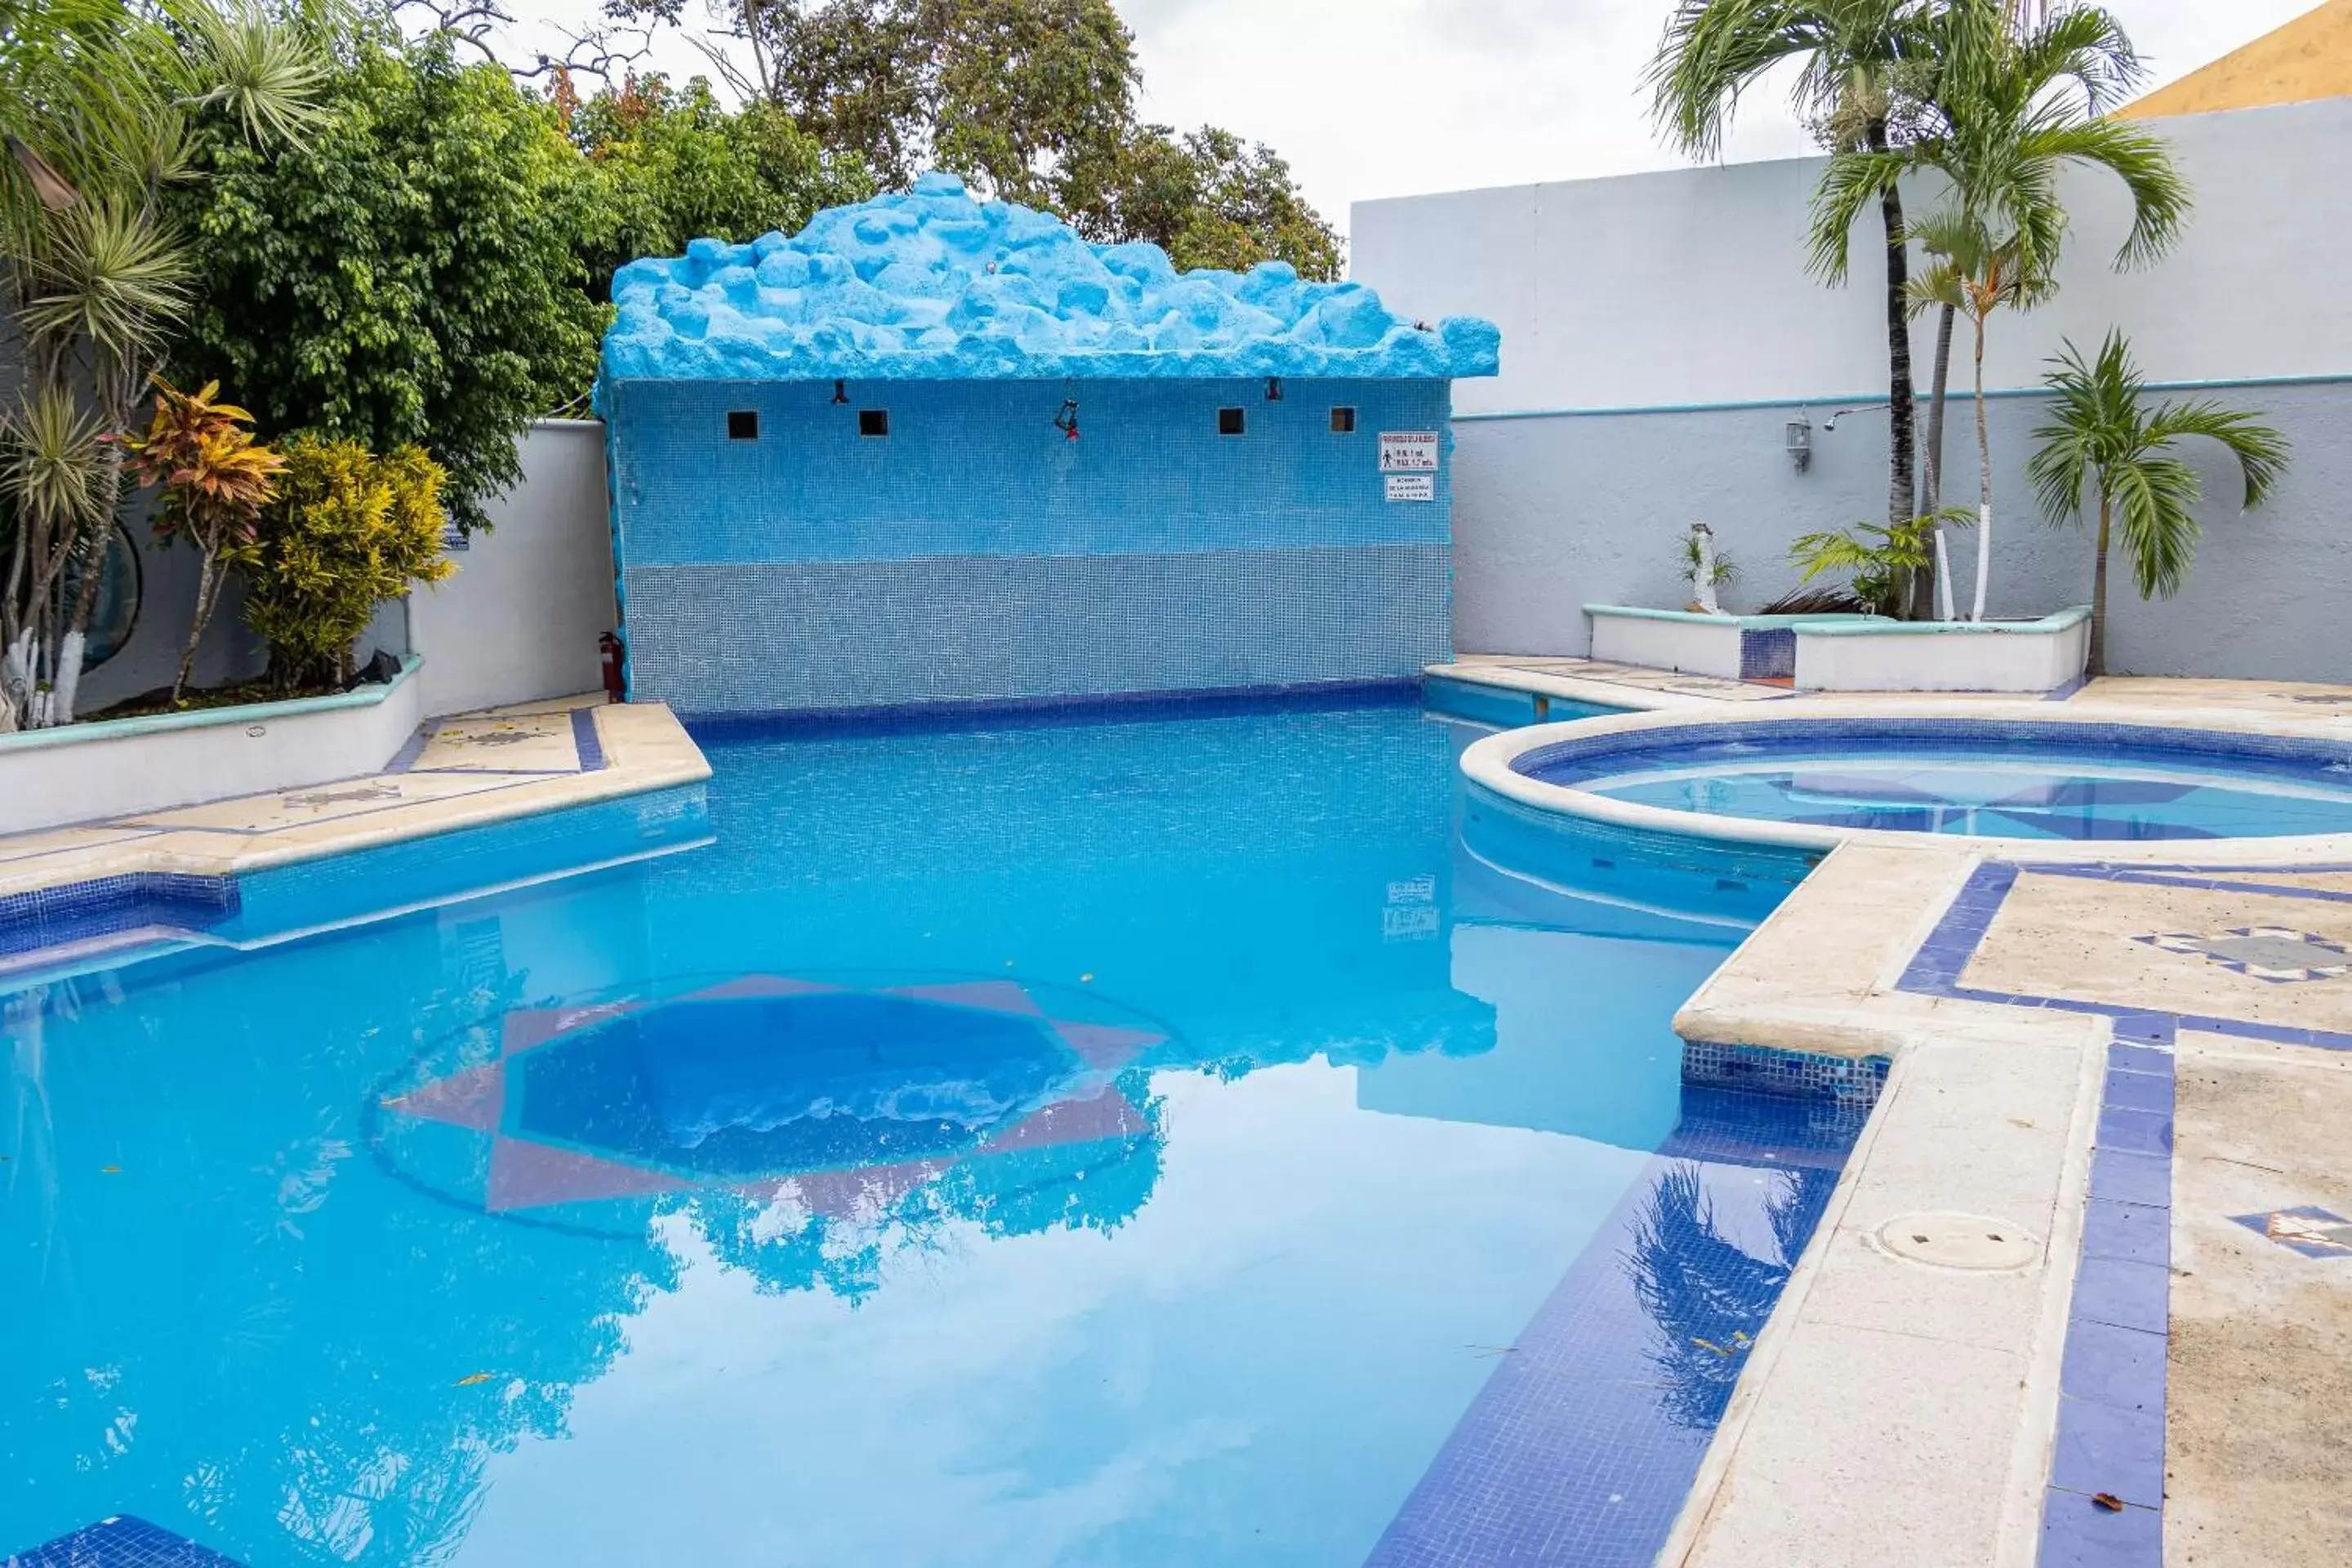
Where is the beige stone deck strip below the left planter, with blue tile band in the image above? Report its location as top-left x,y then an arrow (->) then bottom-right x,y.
0,693 -> 710,910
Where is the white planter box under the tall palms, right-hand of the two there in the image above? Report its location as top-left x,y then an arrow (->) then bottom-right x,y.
1797,604 -> 2091,691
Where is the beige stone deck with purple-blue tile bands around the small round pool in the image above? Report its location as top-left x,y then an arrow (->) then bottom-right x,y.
1432,658 -> 2352,1568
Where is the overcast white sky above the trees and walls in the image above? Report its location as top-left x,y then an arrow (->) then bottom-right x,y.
491,0 -> 2317,228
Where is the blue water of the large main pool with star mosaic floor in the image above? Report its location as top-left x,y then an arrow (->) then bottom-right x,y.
13,703 -> 1853,1568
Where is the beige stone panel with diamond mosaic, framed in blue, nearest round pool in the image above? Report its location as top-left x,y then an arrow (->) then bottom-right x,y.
1962,872 -> 2352,1030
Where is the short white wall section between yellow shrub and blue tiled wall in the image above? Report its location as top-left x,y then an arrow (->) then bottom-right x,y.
407,418 -> 614,715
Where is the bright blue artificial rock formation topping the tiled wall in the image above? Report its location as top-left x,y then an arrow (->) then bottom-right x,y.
599,174 -> 1500,392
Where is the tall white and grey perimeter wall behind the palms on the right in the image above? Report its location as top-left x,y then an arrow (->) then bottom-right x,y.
1350,99 -> 2352,679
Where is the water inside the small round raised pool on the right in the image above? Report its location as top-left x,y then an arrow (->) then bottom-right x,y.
1512,719 -> 2352,840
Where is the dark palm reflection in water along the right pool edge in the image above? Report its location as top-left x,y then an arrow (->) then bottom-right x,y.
1625,1161 -> 1837,1432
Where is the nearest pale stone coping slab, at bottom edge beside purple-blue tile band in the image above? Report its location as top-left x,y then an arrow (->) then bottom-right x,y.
1682,1324 -> 2025,1568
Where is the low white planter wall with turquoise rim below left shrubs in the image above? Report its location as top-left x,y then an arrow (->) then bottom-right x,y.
0,656 -> 425,832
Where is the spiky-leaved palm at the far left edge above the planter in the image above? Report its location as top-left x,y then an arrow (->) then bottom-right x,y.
0,0 -> 323,728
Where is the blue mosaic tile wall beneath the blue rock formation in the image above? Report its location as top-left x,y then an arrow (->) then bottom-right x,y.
607,381 -> 1451,715
